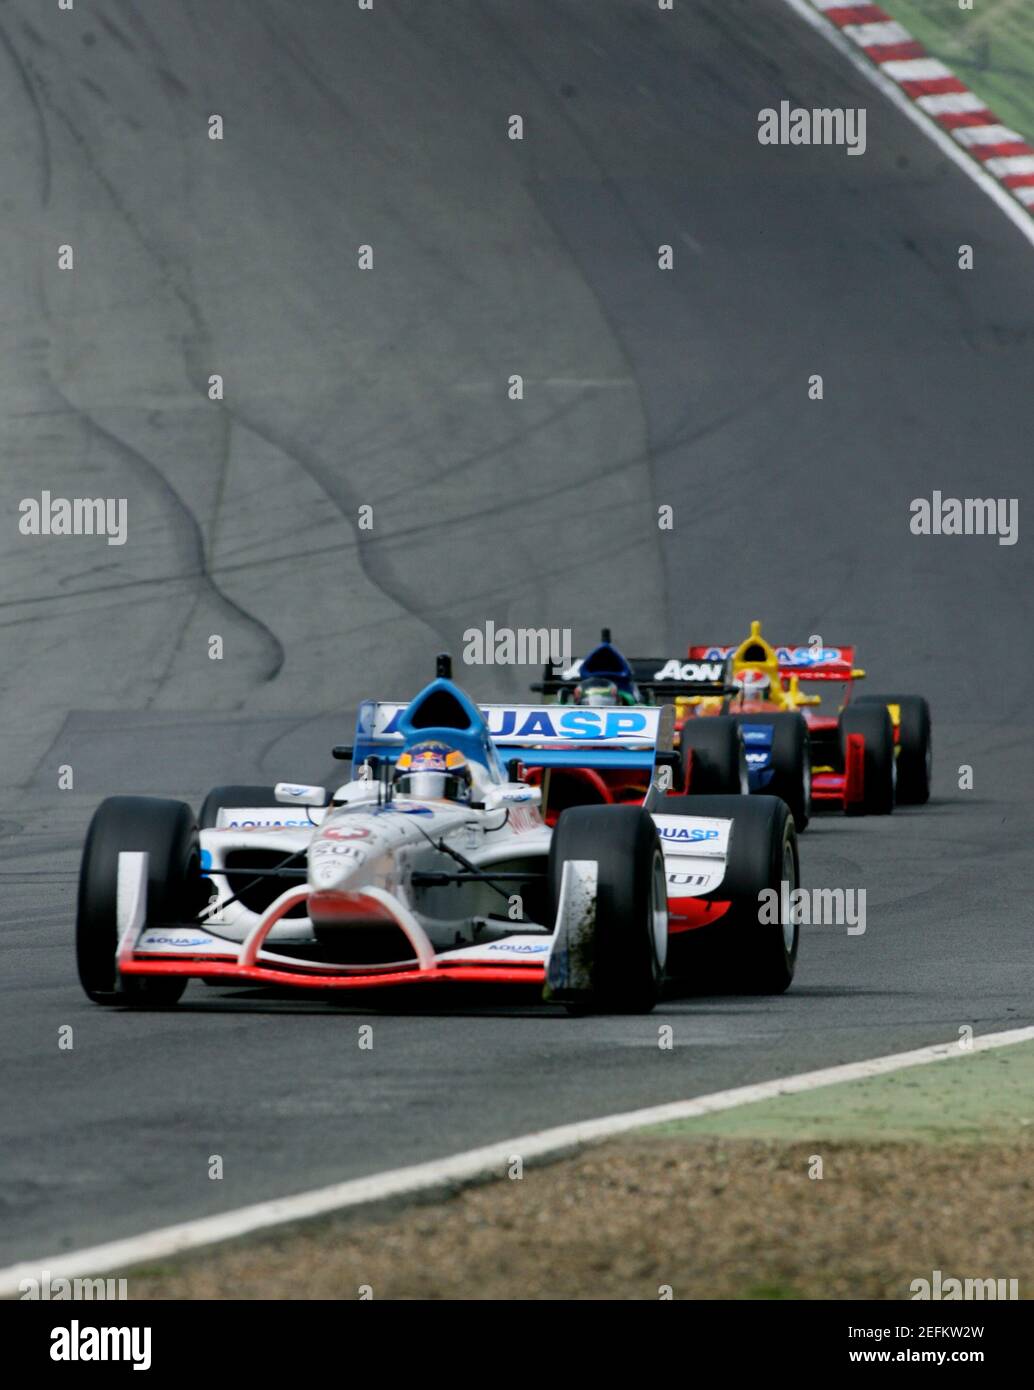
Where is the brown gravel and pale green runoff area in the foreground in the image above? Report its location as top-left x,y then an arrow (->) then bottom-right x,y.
128,1044 -> 1034,1300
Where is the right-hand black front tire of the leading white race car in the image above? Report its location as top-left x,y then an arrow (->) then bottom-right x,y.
549,798 -> 667,1013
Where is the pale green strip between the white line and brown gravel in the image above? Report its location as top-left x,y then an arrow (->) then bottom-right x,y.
648,1043 -> 1034,1144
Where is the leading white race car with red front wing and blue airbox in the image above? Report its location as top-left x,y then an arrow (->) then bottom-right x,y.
76,662 -> 798,1013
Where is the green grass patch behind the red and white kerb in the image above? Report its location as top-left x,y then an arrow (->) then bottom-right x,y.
883,0 -> 1034,142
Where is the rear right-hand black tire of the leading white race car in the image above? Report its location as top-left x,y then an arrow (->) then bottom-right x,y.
663,795 -> 801,994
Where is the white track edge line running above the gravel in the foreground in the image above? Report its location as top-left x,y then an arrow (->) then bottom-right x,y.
0,1027 -> 1034,1298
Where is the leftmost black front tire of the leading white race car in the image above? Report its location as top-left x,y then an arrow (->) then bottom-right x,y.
75,796 -> 204,1005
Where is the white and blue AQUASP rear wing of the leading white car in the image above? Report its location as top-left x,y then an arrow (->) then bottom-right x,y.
353,701 -> 675,769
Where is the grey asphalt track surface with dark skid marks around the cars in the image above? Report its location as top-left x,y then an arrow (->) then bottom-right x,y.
0,0 -> 1034,1261
